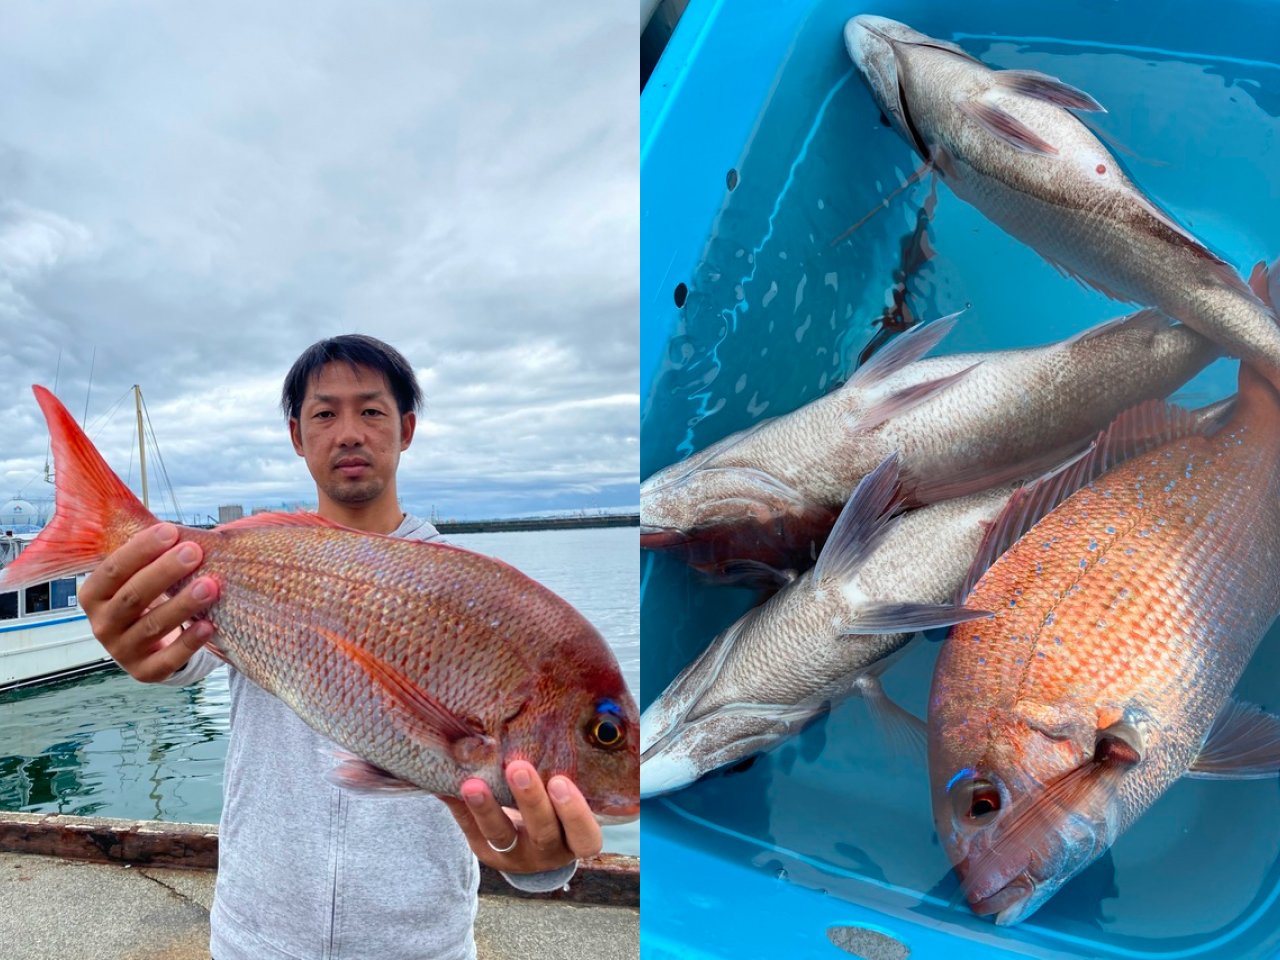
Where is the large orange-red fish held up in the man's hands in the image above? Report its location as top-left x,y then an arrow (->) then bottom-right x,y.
0,387 -> 640,822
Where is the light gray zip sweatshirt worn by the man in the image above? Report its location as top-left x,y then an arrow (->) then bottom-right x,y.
164,516 -> 576,960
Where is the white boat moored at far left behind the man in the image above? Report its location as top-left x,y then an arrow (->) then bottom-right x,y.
0,534 -> 111,691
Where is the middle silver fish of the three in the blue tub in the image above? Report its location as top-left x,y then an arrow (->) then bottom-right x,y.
640,311 -> 1217,581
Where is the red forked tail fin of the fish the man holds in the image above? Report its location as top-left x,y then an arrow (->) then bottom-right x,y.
0,385 -> 157,590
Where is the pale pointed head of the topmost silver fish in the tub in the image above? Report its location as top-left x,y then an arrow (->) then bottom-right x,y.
845,14 -> 974,157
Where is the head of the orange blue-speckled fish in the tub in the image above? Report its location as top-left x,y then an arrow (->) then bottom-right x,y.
929,717 -> 1124,925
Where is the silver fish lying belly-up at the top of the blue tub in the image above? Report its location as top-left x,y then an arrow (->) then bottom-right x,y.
845,15 -> 1280,385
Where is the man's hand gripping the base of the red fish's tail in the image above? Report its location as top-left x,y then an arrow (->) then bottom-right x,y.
79,524 -> 218,684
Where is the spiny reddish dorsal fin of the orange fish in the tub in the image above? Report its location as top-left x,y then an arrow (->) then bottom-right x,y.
956,401 -> 1217,603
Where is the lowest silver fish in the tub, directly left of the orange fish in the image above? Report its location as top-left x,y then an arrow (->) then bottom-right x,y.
640,457 -> 1015,797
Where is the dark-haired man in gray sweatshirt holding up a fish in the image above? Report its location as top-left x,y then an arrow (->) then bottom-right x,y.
81,335 -> 600,960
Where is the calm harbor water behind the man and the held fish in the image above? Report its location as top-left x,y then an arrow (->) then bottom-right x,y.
0,527 -> 640,854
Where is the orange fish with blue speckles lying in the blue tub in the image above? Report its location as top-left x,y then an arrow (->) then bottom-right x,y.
929,321 -> 1280,924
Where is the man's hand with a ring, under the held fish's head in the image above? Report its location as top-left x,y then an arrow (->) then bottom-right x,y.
442,760 -> 603,873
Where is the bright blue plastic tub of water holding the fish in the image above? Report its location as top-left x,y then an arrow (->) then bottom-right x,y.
641,0 -> 1280,960
